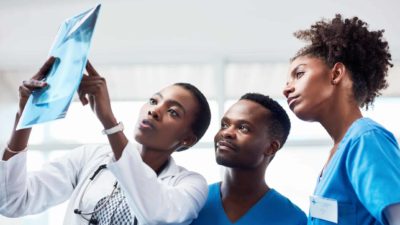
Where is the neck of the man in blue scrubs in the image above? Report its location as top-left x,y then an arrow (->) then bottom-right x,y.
221,166 -> 269,201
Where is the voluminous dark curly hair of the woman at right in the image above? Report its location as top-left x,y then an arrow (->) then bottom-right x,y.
292,14 -> 393,109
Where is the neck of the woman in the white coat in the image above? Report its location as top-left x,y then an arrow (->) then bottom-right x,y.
140,146 -> 172,174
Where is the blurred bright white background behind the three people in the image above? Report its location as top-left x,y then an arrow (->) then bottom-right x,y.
0,0 -> 400,225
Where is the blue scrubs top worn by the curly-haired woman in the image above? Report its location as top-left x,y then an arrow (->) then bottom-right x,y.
308,118 -> 400,225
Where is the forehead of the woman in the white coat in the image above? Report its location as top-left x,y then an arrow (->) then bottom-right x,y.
159,85 -> 199,114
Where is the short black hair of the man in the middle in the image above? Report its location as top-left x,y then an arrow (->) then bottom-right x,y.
240,93 -> 290,148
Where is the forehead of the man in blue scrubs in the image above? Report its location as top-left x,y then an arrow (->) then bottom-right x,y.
224,100 -> 270,124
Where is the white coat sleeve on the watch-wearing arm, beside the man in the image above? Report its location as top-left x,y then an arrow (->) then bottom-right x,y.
108,143 -> 208,224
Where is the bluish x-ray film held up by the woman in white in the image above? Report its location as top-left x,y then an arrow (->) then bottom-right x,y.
17,4 -> 101,129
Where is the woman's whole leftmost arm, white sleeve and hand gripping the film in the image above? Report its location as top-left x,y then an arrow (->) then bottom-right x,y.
0,57 -> 85,217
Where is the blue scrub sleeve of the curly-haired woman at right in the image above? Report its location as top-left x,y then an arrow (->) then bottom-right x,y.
346,130 -> 400,224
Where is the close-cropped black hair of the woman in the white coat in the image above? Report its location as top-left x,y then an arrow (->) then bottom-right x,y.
174,83 -> 211,145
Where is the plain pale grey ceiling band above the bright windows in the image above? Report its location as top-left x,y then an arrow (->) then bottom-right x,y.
0,0 -> 400,70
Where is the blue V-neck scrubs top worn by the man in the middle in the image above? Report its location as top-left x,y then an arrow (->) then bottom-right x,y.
192,183 -> 307,225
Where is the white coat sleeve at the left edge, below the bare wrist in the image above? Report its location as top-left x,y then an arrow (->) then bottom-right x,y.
0,145 -> 84,217
